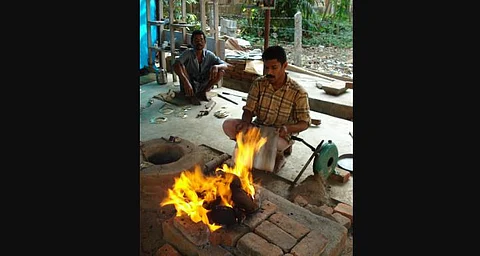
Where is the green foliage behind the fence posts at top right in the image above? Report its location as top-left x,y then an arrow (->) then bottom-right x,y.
238,0 -> 353,47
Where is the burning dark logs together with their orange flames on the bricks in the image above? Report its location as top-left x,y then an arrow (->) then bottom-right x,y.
160,128 -> 266,231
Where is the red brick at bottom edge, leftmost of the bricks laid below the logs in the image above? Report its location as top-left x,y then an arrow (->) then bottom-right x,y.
236,232 -> 283,256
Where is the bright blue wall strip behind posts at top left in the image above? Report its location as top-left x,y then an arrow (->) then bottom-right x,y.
140,0 -> 157,69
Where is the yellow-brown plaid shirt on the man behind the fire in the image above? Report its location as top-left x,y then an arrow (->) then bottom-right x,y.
243,75 -> 311,128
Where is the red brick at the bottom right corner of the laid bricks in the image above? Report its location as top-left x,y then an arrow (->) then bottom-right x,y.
290,230 -> 328,256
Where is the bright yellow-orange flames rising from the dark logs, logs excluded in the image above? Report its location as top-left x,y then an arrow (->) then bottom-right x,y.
160,127 -> 267,232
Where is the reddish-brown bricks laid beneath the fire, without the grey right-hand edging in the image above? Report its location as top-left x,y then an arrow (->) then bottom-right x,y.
156,200 -> 328,256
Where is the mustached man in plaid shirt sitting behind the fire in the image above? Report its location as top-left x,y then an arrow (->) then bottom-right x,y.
223,46 -> 311,172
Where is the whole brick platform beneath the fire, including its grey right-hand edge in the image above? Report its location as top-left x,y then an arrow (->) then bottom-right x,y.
162,186 -> 347,256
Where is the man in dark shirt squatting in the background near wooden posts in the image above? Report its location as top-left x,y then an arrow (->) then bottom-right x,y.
173,30 -> 230,105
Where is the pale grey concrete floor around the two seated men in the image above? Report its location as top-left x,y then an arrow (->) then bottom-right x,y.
140,74 -> 353,206
